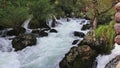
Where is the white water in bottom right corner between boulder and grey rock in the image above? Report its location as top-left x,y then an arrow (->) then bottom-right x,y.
97,44 -> 120,68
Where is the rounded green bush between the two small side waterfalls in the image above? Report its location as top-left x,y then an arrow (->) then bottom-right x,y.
30,0 -> 53,22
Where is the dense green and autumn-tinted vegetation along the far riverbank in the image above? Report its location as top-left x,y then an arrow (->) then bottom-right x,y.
0,0 -> 115,28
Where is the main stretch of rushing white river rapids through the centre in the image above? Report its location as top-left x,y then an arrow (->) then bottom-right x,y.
0,19 -> 89,68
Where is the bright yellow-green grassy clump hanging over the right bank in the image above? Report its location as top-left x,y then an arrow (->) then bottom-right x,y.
95,21 -> 115,53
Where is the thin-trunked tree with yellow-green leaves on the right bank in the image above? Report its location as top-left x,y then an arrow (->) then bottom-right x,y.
90,0 -> 115,29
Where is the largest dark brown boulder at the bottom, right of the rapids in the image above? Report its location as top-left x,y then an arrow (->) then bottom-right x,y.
59,45 -> 95,68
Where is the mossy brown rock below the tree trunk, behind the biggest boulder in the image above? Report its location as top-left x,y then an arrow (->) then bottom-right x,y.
78,31 -> 113,54
